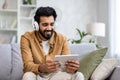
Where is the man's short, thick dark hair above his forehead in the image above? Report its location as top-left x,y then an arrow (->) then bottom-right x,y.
34,6 -> 57,23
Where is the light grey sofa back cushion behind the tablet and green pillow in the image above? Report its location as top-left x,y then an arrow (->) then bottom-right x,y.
70,43 -> 96,60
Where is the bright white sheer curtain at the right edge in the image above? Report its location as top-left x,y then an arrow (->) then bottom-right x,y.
109,0 -> 120,57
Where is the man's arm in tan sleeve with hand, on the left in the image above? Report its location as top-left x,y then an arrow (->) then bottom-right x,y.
21,36 -> 60,75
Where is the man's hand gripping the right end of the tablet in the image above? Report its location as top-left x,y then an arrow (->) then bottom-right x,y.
65,60 -> 79,73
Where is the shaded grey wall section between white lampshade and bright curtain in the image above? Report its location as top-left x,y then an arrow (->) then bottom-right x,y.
97,0 -> 109,46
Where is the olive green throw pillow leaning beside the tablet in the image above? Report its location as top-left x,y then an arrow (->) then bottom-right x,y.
78,48 -> 107,80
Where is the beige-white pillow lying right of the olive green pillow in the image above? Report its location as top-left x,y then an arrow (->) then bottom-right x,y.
91,59 -> 117,80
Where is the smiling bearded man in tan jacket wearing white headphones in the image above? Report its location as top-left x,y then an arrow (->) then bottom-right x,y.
21,7 -> 84,80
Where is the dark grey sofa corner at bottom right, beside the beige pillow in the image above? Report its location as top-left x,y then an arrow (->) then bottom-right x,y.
107,66 -> 120,80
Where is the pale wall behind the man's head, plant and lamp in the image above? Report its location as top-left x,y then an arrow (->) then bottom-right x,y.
37,0 -> 109,47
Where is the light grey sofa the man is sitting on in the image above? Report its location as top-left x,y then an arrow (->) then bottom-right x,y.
0,43 -> 120,80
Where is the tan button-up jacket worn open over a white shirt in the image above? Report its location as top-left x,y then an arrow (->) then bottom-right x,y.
20,31 -> 70,74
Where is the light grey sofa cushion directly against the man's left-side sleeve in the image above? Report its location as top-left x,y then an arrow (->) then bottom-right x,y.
11,44 -> 23,80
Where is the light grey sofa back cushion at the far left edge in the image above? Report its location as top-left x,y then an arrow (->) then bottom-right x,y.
0,44 -> 12,80
